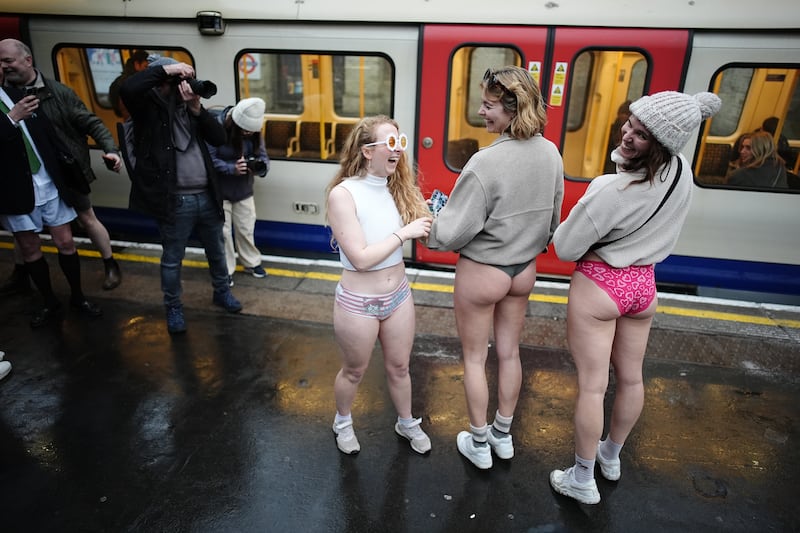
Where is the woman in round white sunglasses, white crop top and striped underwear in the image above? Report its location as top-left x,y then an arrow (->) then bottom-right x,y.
327,116 -> 431,454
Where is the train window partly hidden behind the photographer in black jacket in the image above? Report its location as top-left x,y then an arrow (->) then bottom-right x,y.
55,45 -> 193,144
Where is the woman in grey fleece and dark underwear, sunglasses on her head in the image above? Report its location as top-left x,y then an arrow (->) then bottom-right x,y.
428,66 -> 564,469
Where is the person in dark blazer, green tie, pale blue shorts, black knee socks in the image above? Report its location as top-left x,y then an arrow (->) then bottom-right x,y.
0,80 -> 102,327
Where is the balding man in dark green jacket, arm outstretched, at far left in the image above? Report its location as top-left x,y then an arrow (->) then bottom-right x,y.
0,39 -> 122,290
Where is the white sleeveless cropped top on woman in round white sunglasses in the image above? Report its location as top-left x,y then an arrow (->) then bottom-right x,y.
339,174 -> 403,270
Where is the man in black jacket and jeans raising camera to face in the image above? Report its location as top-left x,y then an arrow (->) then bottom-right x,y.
120,58 -> 242,333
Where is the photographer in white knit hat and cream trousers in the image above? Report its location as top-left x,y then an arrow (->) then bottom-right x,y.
208,98 -> 269,286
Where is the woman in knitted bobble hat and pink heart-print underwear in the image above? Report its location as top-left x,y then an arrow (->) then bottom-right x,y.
550,91 -> 722,504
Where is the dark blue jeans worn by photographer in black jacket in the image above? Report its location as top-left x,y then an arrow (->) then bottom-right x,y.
158,192 -> 230,307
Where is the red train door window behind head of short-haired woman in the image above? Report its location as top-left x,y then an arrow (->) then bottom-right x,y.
444,46 -> 522,171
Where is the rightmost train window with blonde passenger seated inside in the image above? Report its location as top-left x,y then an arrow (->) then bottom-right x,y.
695,64 -> 800,192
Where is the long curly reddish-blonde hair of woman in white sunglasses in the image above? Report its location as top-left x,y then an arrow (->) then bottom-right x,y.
325,115 -> 430,224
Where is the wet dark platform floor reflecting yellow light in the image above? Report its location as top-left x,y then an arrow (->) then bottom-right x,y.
0,239 -> 800,533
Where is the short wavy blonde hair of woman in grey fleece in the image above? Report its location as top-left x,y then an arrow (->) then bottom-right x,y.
481,65 -> 547,139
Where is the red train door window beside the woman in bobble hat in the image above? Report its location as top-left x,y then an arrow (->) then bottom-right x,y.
562,50 -> 648,178
